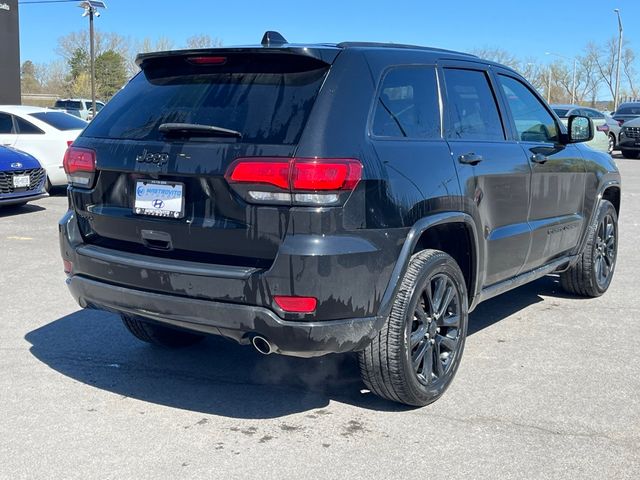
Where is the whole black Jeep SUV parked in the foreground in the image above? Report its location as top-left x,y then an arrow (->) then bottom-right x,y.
60,32 -> 620,405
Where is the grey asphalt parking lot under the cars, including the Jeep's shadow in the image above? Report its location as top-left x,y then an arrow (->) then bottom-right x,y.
0,159 -> 640,479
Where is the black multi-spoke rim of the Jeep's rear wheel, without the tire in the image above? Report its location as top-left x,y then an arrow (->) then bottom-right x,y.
407,274 -> 461,385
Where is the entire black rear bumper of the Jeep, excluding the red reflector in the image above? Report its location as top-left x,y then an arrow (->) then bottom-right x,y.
59,212 -> 406,357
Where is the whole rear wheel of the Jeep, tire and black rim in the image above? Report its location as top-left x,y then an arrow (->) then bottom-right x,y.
359,250 -> 468,407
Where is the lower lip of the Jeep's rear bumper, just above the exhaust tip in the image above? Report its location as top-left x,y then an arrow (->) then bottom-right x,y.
67,275 -> 379,357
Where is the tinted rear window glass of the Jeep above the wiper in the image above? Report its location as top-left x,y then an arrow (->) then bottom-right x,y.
84,62 -> 328,145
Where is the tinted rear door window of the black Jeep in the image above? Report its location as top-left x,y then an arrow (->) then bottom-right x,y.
444,68 -> 504,141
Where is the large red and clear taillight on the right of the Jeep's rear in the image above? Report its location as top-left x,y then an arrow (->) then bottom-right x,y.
225,157 -> 362,205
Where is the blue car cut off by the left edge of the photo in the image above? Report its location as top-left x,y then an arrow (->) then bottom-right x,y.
0,147 -> 48,206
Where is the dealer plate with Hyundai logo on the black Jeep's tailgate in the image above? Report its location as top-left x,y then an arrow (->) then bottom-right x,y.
133,180 -> 184,218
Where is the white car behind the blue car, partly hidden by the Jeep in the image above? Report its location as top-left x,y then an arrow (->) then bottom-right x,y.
0,105 -> 87,187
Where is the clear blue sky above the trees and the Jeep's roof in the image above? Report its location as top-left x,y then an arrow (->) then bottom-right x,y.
20,0 -> 640,62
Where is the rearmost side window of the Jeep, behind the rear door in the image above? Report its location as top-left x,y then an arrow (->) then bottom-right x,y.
372,67 -> 440,139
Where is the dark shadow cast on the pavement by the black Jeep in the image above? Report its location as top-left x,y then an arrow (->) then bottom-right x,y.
25,277 -> 559,419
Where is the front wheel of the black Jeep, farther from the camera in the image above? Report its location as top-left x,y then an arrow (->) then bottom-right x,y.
560,200 -> 618,297
